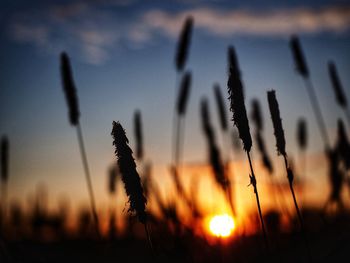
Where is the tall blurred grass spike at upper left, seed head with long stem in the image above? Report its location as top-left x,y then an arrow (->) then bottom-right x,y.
61,52 -> 100,237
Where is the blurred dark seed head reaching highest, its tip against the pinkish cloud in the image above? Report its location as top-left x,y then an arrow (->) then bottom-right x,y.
175,16 -> 193,72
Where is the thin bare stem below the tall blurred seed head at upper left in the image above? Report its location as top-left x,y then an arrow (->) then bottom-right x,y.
77,123 -> 100,237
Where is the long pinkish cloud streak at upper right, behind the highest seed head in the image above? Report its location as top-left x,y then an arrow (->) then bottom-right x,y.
143,6 -> 350,37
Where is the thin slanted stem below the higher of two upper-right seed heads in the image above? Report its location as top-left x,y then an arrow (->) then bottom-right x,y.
304,78 -> 330,148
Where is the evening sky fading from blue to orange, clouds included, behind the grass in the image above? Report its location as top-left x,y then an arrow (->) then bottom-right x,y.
0,0 -> 350,221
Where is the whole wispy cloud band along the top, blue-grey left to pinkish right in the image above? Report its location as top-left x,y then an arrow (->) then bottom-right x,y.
10,3 -> 350,64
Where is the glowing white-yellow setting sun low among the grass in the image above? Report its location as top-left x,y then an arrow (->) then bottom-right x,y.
209,214 -> 235,238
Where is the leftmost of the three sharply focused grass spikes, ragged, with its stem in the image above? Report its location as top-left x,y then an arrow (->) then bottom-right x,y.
111,121 -> 154,252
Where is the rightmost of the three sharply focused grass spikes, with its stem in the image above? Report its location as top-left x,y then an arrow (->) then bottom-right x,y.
267,90 -> 310,260
